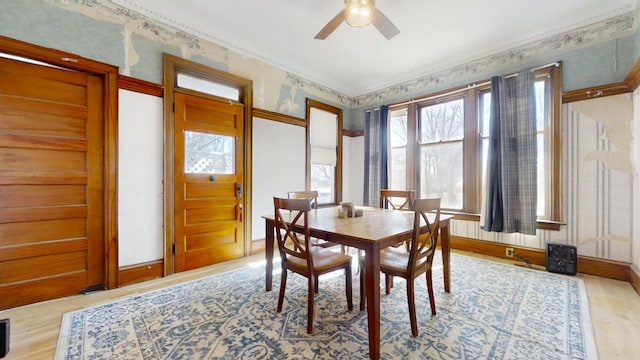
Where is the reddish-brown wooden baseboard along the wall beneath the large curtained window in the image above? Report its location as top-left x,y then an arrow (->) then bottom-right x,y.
451,236 -> 640,282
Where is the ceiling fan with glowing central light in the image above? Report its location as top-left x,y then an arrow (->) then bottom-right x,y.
314,0 -> 400,40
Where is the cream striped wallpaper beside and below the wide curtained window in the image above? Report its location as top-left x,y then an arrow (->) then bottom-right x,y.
452,94 -> 637,262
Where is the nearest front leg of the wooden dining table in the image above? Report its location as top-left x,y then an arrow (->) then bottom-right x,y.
365,243 -> 380,359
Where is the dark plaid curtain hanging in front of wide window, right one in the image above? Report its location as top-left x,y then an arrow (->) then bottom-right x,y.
481,70 -> 538,235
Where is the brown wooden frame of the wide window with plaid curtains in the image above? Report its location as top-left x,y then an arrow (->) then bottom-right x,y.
390,62 -> 562,230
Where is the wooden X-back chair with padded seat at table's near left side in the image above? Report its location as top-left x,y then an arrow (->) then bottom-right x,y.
273,197 -> 353,334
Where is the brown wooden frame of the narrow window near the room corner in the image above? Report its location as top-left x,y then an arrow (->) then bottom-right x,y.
305,98 -> 342,207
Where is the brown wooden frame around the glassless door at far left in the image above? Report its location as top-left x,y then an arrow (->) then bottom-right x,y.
0,35 -> 118,289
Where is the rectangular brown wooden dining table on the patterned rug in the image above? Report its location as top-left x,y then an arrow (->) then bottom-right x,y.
263,207 -> 453,359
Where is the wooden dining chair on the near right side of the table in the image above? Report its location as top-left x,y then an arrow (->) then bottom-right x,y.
360,198 -> 440,336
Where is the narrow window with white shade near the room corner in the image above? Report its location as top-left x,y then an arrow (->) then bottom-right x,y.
307,100 -> 342,205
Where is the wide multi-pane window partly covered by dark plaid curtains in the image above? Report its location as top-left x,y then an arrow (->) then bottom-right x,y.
389,66 -> 561,221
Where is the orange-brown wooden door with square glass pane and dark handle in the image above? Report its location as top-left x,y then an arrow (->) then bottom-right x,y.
174,91 -> 244,272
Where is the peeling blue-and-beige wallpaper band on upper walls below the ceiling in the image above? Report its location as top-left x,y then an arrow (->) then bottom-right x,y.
0,0 -> 640,126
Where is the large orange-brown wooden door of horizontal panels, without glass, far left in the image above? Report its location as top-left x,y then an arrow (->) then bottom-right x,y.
0,58 -> 104,309
